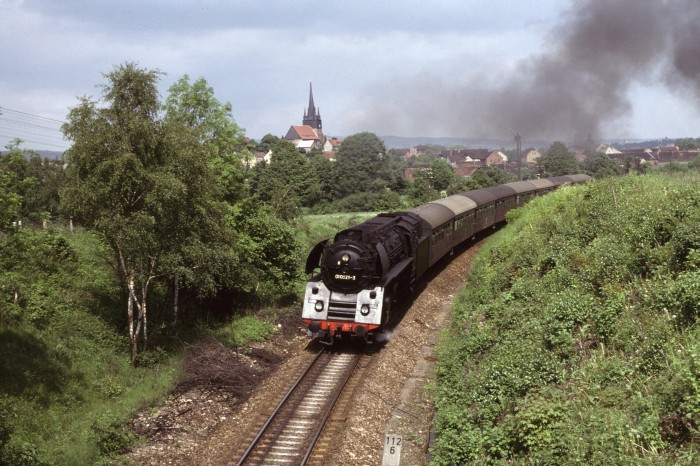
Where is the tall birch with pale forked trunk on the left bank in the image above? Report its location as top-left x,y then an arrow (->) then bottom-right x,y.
62,63 -> 223,365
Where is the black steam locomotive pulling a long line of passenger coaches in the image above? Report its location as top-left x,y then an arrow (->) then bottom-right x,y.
302,174 -> 591,344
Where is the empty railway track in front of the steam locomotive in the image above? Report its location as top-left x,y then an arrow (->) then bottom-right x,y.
236,348 -> 366,466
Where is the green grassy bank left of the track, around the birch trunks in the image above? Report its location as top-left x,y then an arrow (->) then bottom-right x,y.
0,229 -> 275,465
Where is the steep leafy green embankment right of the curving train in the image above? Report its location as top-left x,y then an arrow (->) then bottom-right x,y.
433,174 -> 700,465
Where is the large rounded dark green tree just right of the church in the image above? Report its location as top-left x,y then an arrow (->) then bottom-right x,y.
336,132 -> 389,198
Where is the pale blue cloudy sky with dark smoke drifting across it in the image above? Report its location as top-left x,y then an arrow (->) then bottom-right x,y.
0,0 -> 700,150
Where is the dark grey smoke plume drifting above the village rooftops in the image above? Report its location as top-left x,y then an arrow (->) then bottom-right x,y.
352,0 -> 700,141
